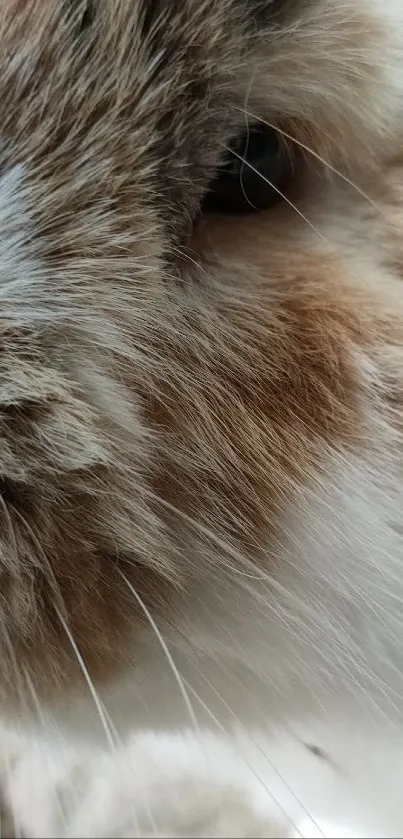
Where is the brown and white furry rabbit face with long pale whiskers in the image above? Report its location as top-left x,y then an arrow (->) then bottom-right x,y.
0,0 -> 403,832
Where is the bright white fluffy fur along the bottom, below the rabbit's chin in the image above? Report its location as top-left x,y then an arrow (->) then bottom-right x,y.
3,725 -> 403,839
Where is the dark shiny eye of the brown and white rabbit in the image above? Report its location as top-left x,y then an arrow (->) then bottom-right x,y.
203,123 -> 291,214
